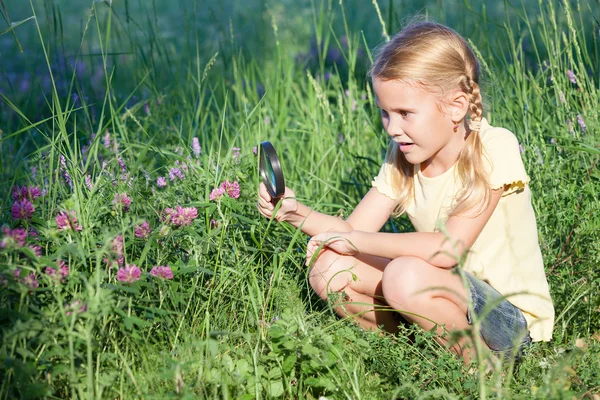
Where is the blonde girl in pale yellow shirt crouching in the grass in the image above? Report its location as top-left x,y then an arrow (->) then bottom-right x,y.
258,22 -> 554,362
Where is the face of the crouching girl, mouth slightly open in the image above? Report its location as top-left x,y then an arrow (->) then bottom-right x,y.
373,78 -> 465,176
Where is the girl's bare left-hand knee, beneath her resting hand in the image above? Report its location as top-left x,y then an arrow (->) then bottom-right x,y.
308,250 -> 353,300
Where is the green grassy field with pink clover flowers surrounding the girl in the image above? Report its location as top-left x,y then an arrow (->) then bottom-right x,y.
0,0 -> 600,399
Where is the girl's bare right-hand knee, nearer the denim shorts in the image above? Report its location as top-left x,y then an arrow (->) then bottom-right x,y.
381,257 -> 425,310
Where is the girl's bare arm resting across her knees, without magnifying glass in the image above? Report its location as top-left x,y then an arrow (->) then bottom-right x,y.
307,190 -> 503,268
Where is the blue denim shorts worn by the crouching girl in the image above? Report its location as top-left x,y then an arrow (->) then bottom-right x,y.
461,270 -> 531,359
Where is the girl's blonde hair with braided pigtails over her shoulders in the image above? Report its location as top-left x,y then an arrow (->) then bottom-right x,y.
369,22 -> 490,216
